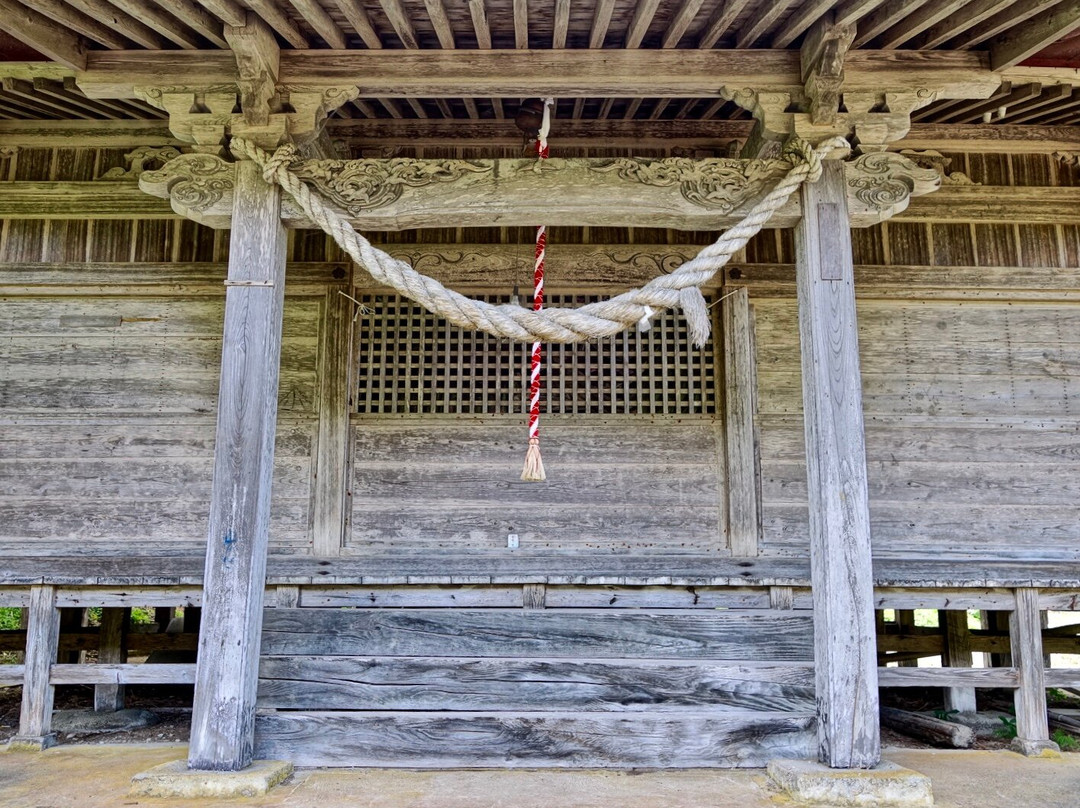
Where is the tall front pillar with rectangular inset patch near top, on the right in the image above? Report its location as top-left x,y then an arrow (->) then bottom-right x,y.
795,161 -> 881,768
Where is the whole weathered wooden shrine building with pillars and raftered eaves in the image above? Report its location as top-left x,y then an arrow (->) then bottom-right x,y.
0,0 -> 1080,790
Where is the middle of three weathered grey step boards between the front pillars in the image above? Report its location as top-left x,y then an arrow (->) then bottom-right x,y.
259,657 -> 813,713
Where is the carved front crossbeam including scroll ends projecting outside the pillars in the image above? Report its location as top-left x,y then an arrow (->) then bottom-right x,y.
139,152 -> 941,230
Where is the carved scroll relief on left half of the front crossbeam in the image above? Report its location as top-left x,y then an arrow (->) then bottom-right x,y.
293,158 -> 494,215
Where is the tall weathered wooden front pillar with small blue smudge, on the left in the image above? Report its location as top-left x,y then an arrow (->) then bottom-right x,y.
188,161 -> 285,771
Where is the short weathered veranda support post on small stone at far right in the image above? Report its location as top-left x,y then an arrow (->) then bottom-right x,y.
1009,588 -> 1057,755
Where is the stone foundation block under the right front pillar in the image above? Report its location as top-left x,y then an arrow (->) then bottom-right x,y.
768,760 -> 934,808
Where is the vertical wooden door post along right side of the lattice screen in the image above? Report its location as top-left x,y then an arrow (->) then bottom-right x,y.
721,288 -> 761,556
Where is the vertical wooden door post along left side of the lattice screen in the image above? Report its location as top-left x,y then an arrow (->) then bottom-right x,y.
311,285 -> 353,556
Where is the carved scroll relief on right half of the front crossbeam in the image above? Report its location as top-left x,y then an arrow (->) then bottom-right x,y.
593,158 -> 789,213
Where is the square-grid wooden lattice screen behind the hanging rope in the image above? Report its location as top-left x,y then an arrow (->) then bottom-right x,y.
356,295 -> 717,416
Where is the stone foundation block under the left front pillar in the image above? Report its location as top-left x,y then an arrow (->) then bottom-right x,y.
129,760 -> 293,799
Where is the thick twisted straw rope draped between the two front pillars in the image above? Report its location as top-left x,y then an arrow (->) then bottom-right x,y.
231,137 -> 848,348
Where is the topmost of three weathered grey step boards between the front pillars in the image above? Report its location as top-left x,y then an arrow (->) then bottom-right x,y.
262,608 -> 813,661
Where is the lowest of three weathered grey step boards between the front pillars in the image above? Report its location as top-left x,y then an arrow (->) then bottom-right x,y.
250,710 -> 814,768
